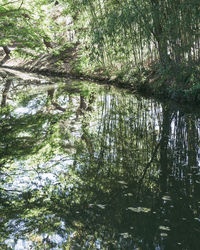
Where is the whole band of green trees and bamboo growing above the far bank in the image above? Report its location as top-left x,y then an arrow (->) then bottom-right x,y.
0,0 -> 200,99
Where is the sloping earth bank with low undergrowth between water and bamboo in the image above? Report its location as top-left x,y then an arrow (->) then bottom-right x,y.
0,46 -> 200,104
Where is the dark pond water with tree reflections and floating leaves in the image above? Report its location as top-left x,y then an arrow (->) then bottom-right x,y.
0,69 -> 200,250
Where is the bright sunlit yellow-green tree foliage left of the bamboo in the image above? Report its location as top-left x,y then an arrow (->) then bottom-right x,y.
0,0 -> 68,56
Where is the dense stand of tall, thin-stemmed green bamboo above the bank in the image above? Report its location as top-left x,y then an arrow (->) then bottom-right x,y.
68,0 -> 200,72
